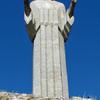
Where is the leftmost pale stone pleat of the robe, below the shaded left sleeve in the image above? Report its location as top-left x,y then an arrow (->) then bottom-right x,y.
33,30 -> 41,96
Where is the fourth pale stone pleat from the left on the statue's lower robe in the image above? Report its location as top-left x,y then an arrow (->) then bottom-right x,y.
53,24 -> 62,97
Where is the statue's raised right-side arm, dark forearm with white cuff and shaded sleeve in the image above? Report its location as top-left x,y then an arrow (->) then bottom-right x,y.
63,0 -> 77,41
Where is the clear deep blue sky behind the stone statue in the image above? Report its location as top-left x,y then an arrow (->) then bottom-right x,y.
0,0 -> 100,100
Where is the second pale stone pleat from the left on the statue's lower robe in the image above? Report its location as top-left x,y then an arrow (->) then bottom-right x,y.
41,25 -> 47,97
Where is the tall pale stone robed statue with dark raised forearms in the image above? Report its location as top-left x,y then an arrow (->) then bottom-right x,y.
24,0 -> 76,100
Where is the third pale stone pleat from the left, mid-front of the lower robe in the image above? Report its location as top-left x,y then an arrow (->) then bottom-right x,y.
46,25 -> 54,97
